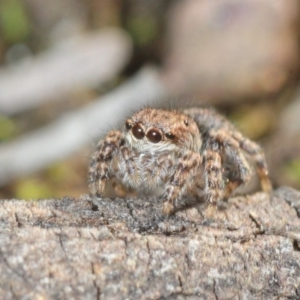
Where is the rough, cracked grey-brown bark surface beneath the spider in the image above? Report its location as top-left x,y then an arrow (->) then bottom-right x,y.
0,187 -> 300,300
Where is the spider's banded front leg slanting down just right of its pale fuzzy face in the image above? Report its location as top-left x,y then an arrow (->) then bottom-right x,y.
163,150 -> 202,215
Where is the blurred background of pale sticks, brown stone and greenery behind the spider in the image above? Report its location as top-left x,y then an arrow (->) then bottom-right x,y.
0,0 -> 300,199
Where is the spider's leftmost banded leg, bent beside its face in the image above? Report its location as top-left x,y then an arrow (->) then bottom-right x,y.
88,130 -> 123,196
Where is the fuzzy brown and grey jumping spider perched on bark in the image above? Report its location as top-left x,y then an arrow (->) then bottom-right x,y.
89,108 -> 272,215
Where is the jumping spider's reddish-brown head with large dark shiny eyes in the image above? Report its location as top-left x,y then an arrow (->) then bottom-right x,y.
125,108 -> 201,152
